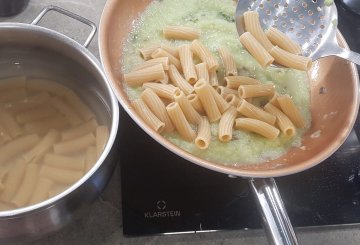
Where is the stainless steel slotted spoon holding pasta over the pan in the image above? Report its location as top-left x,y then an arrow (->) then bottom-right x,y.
235,0 -> 360,65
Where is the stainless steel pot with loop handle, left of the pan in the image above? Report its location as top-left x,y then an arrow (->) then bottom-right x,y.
0,6 -> 119,244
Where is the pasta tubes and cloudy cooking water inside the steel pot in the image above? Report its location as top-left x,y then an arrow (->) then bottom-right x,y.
0,76 -> 109,211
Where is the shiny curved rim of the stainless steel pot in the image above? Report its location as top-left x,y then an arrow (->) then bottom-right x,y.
0,22 -> 119,216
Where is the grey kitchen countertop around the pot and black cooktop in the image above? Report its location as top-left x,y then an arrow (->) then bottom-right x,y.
0,0 -> 360,245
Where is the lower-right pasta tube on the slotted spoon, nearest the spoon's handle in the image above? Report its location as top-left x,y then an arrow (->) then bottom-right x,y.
270,46 -> 312,71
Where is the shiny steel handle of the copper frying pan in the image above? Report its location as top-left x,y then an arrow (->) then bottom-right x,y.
249,178 -> 298,245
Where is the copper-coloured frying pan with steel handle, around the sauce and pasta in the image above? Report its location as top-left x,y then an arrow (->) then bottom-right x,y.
99,0 -> 359,244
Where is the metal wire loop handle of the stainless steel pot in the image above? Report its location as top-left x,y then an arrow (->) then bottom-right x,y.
31,5 -> 96,48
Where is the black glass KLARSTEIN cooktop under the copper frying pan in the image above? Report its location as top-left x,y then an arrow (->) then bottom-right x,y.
119,2 -> 360,236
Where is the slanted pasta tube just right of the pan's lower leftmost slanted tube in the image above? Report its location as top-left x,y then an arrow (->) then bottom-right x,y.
141,88 -> 174,132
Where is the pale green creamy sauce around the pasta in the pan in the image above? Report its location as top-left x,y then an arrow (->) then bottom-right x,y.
122,0 -> 311,164
